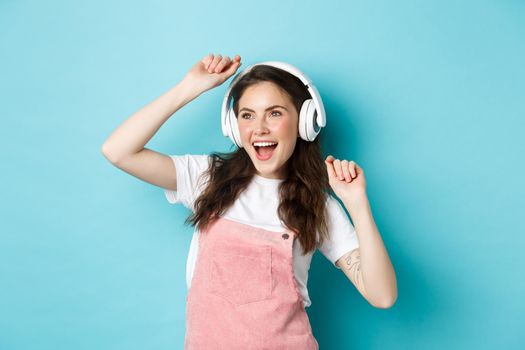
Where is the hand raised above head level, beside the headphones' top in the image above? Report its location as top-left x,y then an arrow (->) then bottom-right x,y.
183,54 -> 241,94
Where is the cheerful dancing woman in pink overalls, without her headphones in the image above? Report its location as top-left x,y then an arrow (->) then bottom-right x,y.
102,54 -> 397,349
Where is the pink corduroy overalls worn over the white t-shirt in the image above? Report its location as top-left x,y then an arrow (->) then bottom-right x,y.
184,217 -> 319,350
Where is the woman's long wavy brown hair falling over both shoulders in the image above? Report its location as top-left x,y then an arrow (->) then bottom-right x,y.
185,65 -> 330,254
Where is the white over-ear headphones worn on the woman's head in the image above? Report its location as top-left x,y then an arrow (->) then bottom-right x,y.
221,61 -> 326,148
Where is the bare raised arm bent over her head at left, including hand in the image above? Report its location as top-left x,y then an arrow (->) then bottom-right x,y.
101,54 -> 241,190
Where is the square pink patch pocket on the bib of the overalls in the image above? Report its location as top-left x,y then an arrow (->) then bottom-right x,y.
208,243 -> 272,305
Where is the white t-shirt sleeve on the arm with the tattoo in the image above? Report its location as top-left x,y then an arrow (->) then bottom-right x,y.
319,195 -> 359,269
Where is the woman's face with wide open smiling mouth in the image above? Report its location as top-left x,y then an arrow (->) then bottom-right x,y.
237,82 -> 299,179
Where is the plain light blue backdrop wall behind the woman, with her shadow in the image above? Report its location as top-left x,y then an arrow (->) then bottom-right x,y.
0,0 -> 525,350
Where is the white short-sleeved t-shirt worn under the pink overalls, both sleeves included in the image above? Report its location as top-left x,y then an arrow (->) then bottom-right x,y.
164,154 -> 359,307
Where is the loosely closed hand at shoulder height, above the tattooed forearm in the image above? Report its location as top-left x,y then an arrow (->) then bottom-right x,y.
324,156 -> 366,203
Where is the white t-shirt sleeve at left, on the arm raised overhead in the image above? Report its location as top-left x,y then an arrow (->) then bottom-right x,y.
164,154 -> 211,211
